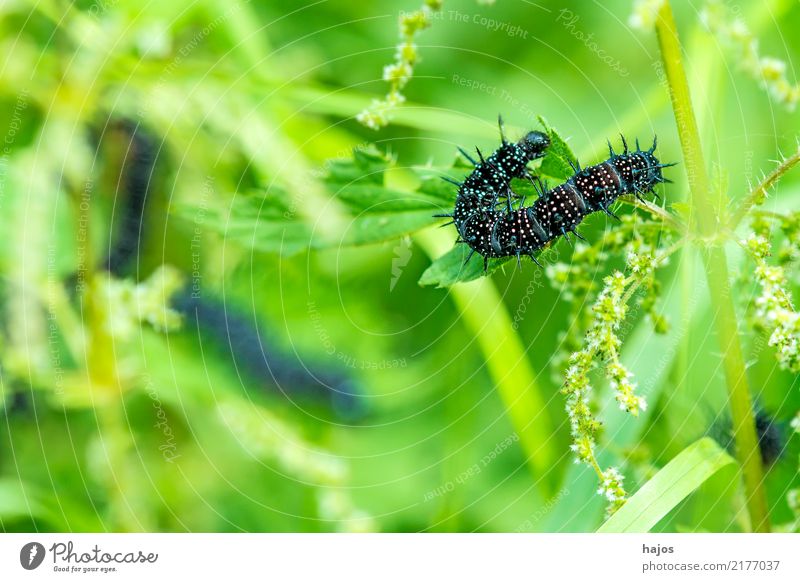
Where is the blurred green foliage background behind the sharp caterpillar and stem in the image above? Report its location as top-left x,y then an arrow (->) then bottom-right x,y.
0,0 -> 800,531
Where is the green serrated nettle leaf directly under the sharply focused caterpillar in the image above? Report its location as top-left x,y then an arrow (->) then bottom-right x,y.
419,123 -> 575,287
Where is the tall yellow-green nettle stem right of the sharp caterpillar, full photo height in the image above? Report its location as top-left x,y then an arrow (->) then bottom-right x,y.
656,0 -> 769,531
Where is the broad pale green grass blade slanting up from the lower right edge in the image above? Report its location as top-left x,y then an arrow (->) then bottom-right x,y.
597,437 -> 735,533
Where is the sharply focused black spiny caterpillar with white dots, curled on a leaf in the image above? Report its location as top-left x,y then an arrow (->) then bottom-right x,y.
436,118 -> 674,271
